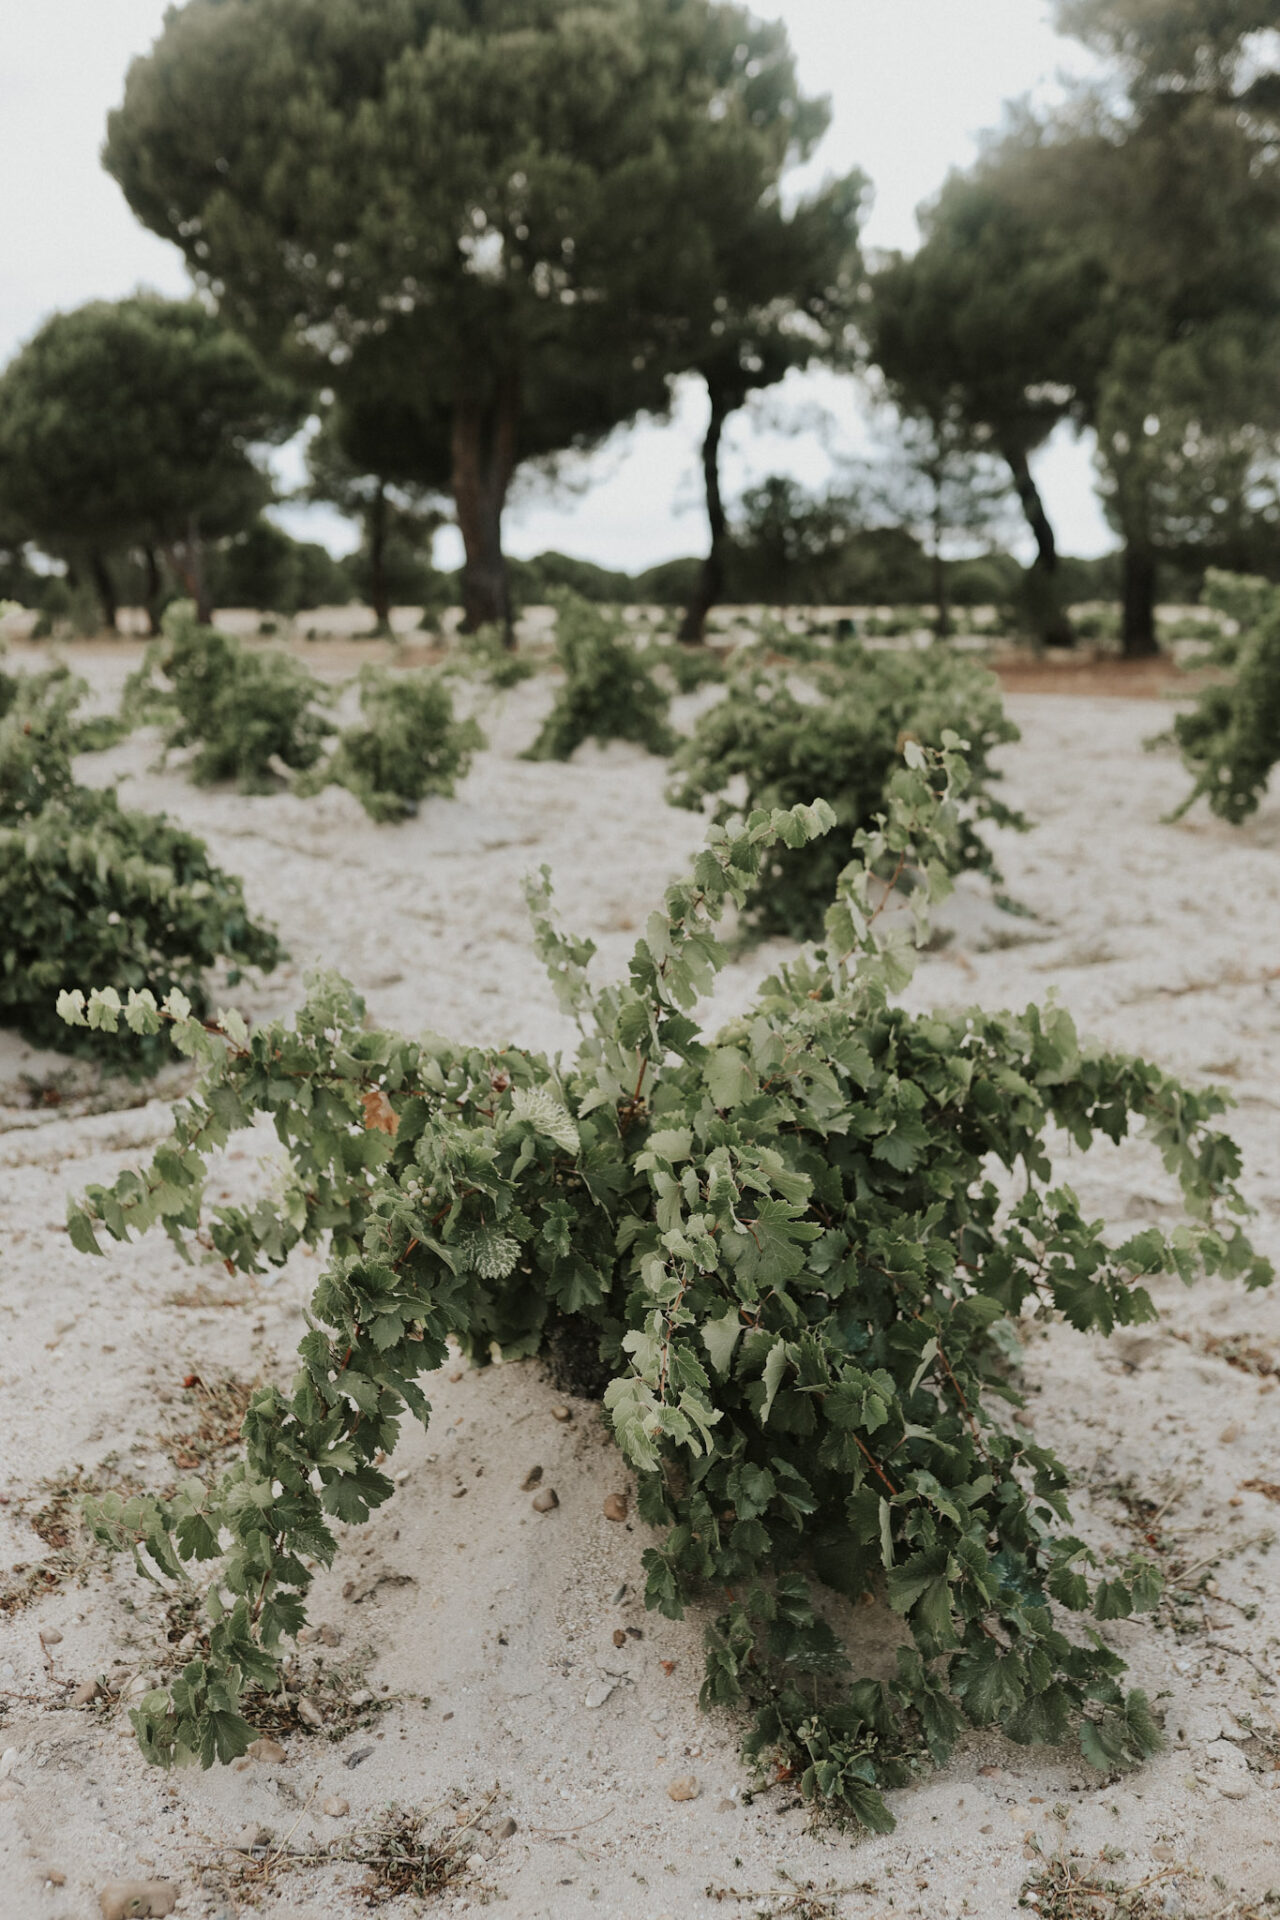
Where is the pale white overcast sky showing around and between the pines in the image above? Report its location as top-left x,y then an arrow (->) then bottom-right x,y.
0,0 -> 1113,568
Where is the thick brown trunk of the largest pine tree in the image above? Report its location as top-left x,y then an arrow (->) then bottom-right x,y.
453,378 -> 520,647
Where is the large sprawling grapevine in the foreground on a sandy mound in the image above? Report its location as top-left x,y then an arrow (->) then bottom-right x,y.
63,749 -> 1270,1828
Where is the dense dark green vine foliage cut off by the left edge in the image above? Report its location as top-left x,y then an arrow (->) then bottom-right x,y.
0,676 -> 280,1069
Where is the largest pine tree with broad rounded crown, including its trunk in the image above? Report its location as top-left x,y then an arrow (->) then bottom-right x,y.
104,0 -> 827,624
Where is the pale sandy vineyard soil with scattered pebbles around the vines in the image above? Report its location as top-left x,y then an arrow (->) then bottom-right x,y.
0,645 -> 1280,1920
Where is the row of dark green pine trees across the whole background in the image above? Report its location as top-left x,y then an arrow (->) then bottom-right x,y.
0,0 -> 1280,653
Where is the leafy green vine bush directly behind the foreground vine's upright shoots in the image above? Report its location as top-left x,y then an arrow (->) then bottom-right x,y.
668,645 -> 1025,939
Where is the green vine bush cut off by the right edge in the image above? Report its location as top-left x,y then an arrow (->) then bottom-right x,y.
1173,572 -> 1280,826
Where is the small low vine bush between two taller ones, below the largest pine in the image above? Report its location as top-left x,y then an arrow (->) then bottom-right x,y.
299,666 -> 484,820
